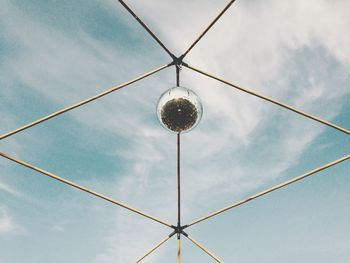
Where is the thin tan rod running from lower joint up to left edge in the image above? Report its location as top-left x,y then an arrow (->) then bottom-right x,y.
0,152 -> 173,228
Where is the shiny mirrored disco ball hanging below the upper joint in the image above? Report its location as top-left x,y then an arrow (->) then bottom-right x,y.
157,87 -> 203,133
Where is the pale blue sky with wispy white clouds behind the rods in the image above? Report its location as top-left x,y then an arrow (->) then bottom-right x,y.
0,0 -> 350,263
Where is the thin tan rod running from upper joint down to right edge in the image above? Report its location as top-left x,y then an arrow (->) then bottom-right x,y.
183,63 -> 350,135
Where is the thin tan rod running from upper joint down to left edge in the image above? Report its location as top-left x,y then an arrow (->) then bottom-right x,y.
0,64 -> 170,140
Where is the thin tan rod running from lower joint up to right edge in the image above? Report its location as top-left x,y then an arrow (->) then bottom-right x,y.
187,154 -> 350,227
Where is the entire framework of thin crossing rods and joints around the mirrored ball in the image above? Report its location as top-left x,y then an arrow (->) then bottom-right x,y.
0,0 -> 350,263
